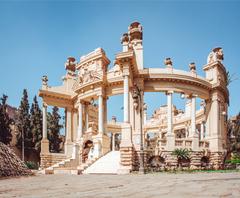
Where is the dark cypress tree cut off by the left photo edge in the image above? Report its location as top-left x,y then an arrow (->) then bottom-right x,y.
0,94 -> 12,144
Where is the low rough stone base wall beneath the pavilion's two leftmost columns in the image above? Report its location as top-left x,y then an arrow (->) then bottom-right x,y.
40,153 -> 67,169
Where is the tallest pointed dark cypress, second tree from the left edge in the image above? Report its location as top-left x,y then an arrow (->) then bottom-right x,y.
16,89 -> 33,150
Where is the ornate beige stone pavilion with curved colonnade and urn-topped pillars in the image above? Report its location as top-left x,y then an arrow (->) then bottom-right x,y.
39,22 -> 229,173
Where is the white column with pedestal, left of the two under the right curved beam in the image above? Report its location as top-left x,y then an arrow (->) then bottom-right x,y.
166,91 -> 175,151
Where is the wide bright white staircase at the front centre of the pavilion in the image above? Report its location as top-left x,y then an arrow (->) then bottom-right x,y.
83,151 -> 120,174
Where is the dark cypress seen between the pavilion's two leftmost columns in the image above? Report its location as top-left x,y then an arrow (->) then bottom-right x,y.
47,107 -> 63,153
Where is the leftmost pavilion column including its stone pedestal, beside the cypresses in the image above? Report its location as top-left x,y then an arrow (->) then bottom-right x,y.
41,102 -> 49,154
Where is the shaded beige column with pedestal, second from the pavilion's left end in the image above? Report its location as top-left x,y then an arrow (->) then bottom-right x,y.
65,107 -> 73,156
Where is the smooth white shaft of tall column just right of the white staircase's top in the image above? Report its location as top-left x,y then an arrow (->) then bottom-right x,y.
123,75 -> 129,123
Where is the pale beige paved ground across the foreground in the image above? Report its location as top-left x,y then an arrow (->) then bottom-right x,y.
0,173 -> 240,198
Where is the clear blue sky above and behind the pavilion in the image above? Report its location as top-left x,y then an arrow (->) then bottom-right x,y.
0,0 -> 240,120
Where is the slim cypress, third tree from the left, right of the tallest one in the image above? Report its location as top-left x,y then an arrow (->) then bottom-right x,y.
30,96 -> 42,152
